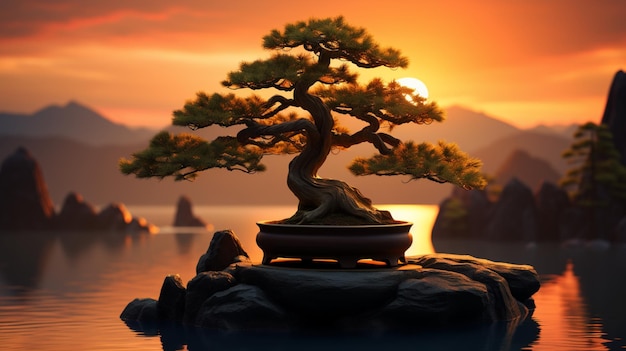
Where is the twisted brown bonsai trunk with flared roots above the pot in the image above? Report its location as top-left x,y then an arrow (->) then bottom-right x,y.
286,80 -> 393,224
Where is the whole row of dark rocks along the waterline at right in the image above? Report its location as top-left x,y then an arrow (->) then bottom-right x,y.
432,179 -> 624,244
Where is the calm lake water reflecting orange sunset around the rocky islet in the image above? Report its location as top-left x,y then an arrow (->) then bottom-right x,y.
0,205 -> 626,350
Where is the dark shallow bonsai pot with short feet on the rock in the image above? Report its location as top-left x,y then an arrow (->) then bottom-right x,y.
256,221 -> 413,268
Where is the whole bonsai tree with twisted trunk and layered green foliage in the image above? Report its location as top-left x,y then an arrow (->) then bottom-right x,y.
120,17 -> 485,224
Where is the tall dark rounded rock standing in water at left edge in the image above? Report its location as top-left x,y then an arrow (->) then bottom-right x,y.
0,147 -> 54,230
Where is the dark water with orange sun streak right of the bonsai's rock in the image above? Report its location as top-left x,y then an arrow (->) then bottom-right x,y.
434,241 -> 626,350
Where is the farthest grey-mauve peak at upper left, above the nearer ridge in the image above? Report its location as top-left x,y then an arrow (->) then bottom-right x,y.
0,102 -> 154,145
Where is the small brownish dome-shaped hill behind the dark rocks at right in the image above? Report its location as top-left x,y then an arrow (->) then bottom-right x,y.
494,150 -> 561,190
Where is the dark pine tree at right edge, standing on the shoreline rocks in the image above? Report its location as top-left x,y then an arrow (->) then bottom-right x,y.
560,122 -> 626,207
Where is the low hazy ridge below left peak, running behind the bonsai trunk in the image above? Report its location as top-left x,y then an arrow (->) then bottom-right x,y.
0,136 -> 451,206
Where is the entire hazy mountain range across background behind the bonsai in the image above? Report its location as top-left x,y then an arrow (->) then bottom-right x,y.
0,102 -> 571,206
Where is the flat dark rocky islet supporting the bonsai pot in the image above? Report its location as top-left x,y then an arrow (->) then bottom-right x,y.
120,231 -> 540,330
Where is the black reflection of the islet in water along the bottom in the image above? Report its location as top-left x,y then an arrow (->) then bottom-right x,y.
120,319 -> 539,351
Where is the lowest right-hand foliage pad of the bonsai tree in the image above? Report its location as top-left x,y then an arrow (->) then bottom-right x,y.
349,141 -> 486,189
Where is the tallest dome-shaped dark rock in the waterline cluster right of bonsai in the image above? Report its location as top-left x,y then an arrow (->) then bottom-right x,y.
485,178 -> 537,241
